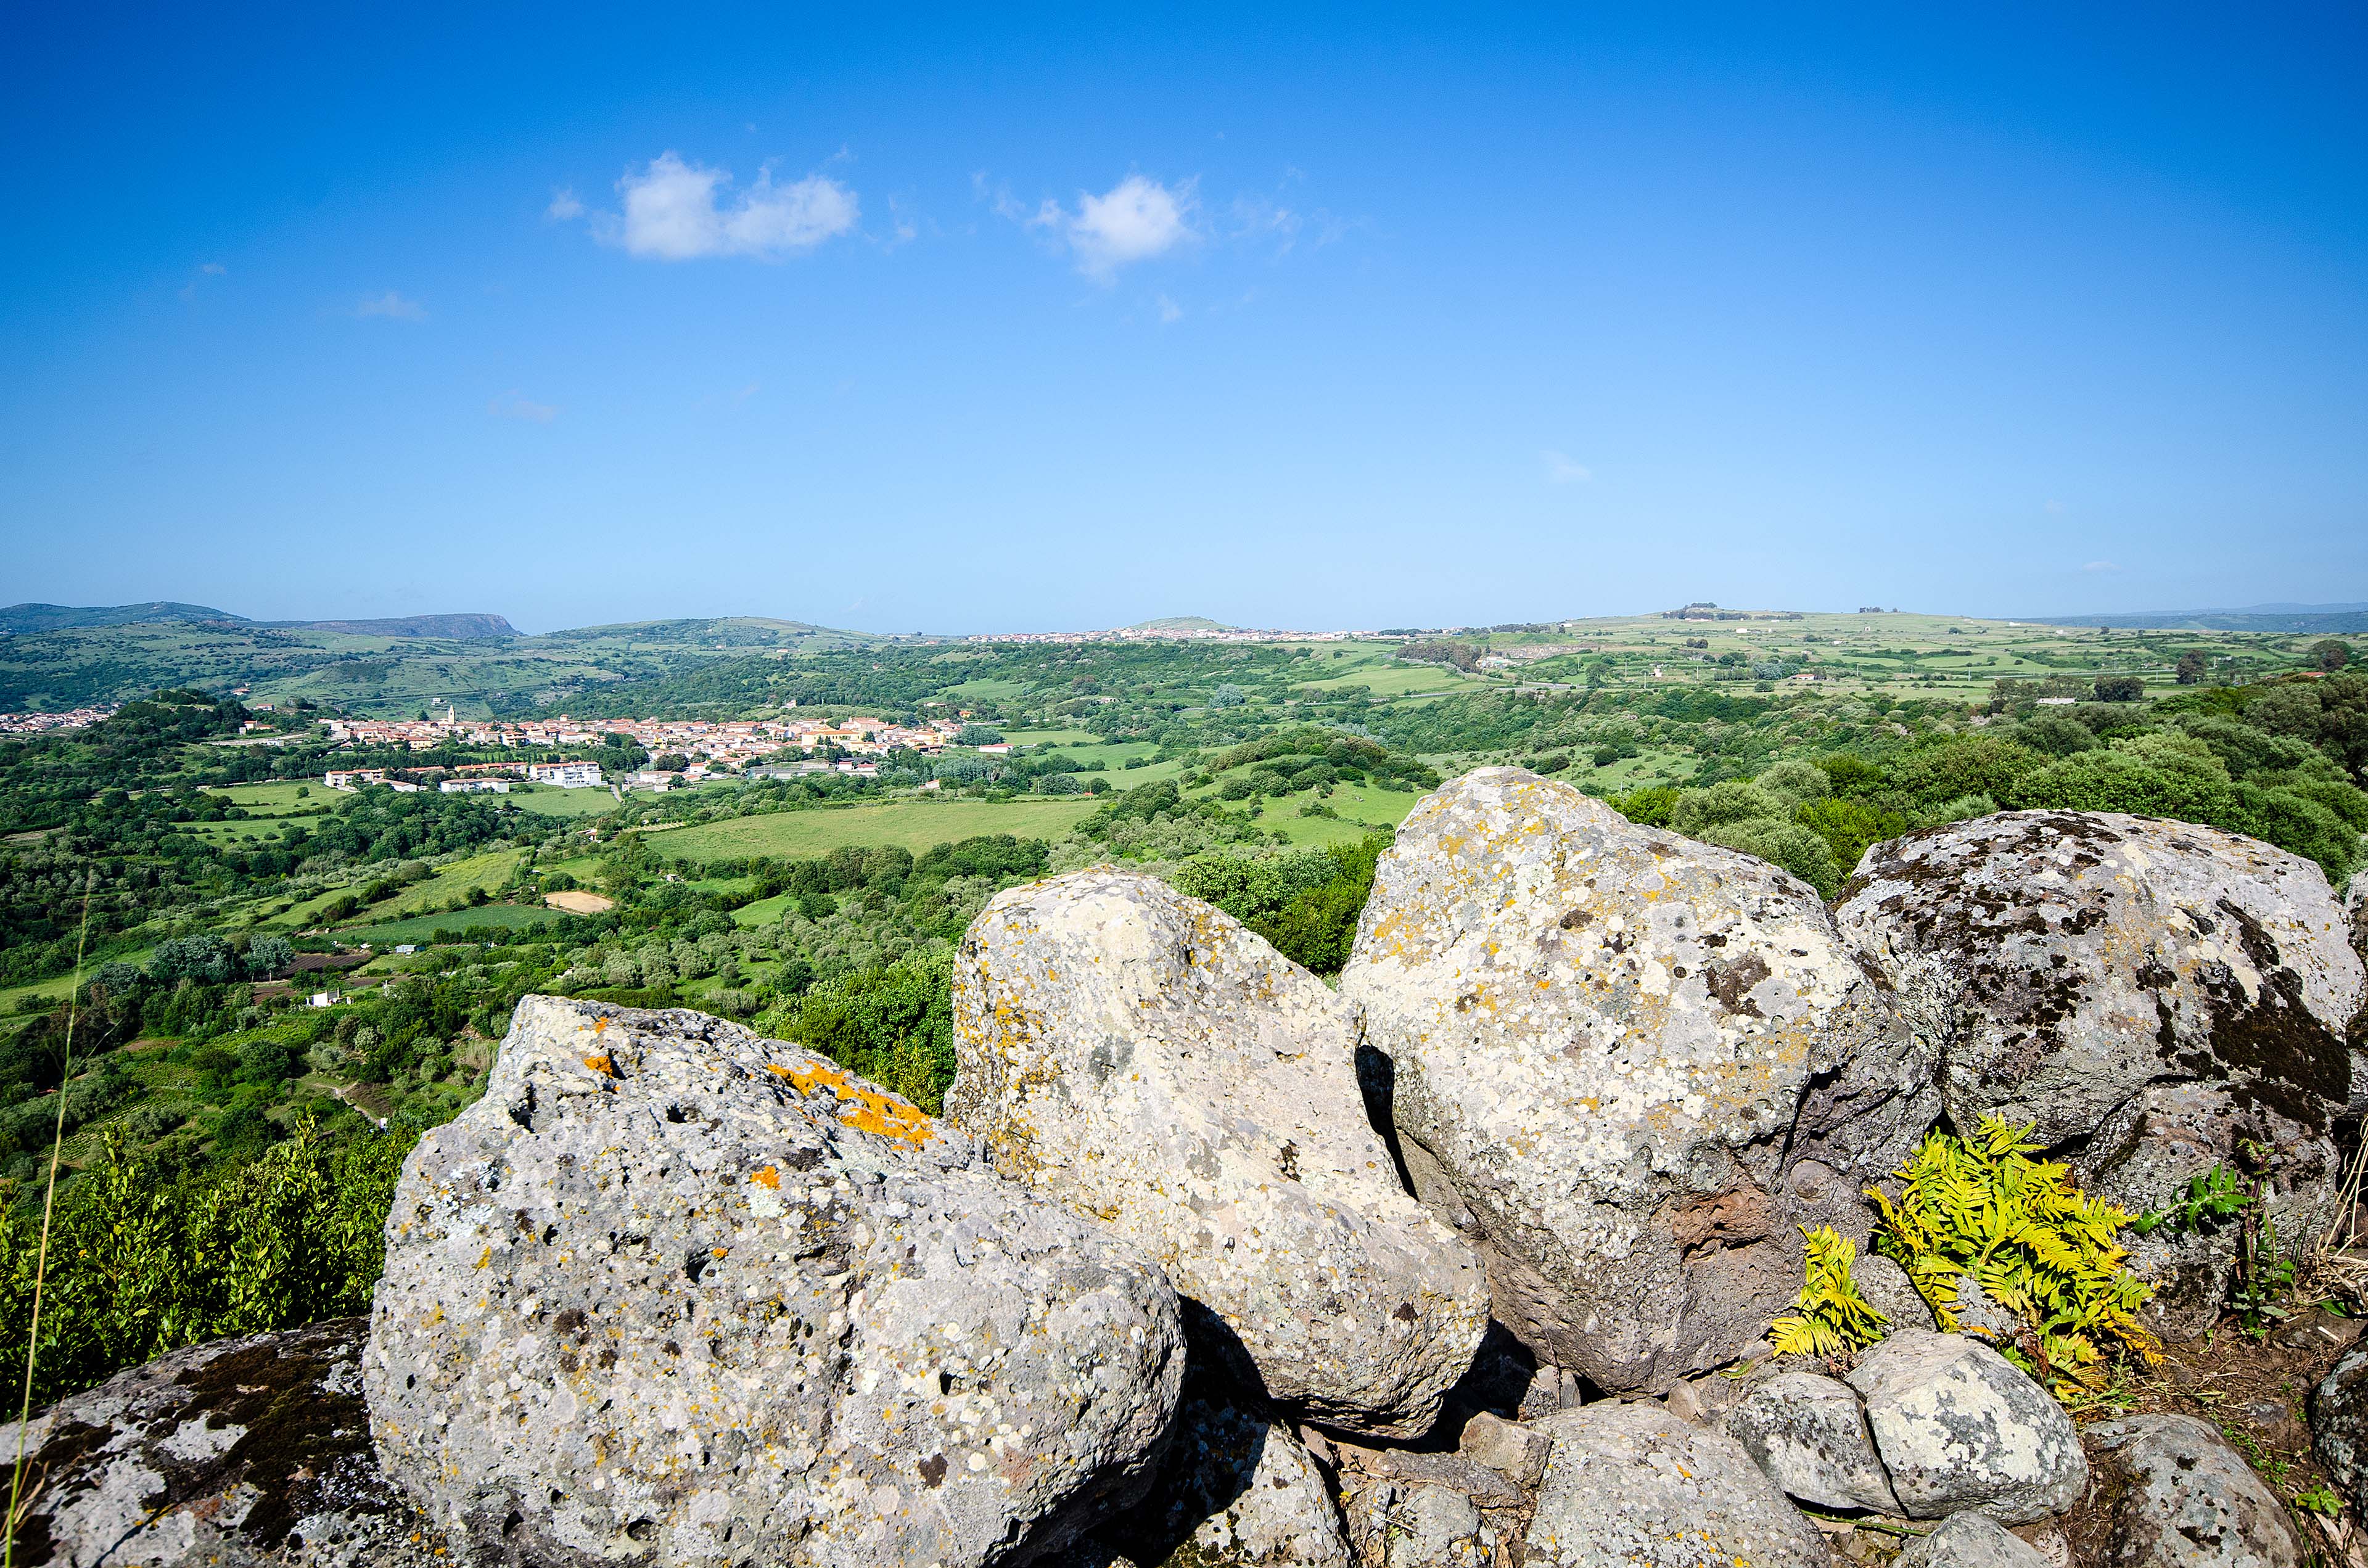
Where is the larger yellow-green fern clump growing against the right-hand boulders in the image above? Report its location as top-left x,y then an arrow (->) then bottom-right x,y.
1866,1115 -> 2162,1393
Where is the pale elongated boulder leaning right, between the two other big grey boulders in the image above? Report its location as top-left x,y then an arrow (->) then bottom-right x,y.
945,867 -> 1487,1435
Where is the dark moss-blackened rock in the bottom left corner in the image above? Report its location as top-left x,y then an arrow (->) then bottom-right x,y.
0,1317 -> 452,1568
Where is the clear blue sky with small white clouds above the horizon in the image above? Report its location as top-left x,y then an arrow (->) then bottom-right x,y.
0,7 -> 2368,630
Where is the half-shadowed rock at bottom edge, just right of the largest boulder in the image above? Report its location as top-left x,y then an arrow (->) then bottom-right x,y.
1101,1374 -> 1350,1568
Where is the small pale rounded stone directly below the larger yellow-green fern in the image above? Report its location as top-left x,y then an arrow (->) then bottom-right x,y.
1849,1334 -> 2089,1525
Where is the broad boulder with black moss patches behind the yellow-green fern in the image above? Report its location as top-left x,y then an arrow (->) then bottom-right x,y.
1835,810 -> 2368,1144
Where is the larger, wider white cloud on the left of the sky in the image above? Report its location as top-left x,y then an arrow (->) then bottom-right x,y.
615,152 -> 857,261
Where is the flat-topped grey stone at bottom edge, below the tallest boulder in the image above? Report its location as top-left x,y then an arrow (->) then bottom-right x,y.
1525,1400 -> 1833,1568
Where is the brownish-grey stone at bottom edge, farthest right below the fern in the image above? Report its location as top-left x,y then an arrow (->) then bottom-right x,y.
2086,1416 -> 2304,1568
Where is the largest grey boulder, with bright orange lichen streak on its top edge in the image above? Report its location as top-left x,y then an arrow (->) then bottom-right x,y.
364,997 -> 1184,1568
